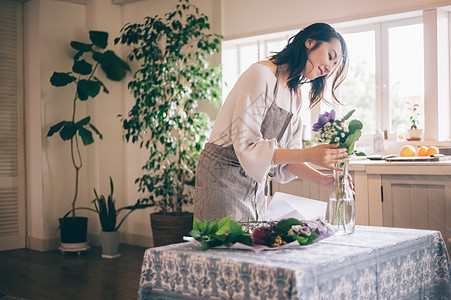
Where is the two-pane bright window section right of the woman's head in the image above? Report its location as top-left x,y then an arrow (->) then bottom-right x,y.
338,18 -> 424,136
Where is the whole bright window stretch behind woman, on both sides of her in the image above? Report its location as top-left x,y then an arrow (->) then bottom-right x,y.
222,17 -> 425,139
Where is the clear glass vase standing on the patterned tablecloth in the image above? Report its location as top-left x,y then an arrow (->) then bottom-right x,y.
329,162 -> 355,235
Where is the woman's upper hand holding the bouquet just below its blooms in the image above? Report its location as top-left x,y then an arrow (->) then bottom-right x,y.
303,143 -> 348,171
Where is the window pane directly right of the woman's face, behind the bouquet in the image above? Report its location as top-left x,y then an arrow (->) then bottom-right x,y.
339,31 -> 376,133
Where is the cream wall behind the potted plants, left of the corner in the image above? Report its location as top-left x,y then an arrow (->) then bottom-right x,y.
25,0 -> 220,250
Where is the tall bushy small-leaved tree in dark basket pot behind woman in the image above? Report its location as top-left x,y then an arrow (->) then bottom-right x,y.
115,0 -> 222,246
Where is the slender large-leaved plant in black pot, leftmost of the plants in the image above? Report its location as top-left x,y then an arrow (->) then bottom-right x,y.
47,31 -> 130,251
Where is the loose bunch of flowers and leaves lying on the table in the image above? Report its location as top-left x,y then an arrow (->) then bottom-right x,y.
190,216 -> 335,251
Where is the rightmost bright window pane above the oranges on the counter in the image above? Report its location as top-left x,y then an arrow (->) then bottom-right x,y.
388,24 -> 424,131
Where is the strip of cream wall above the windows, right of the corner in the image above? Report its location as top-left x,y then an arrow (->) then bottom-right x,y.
222,0 -> 451,39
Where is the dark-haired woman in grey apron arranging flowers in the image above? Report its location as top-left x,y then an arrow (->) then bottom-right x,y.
194,23 -> 347,221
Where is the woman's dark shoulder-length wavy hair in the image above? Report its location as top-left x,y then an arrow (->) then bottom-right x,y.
270,23 -> 348,108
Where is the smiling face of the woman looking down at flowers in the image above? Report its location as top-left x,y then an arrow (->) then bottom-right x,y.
302,39 -> 341,80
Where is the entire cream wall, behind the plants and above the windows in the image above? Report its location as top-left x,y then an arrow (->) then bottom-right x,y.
24,0 -> 451,250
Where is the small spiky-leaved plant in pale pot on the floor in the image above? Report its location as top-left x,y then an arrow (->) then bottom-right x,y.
63,177 -> 153,258
